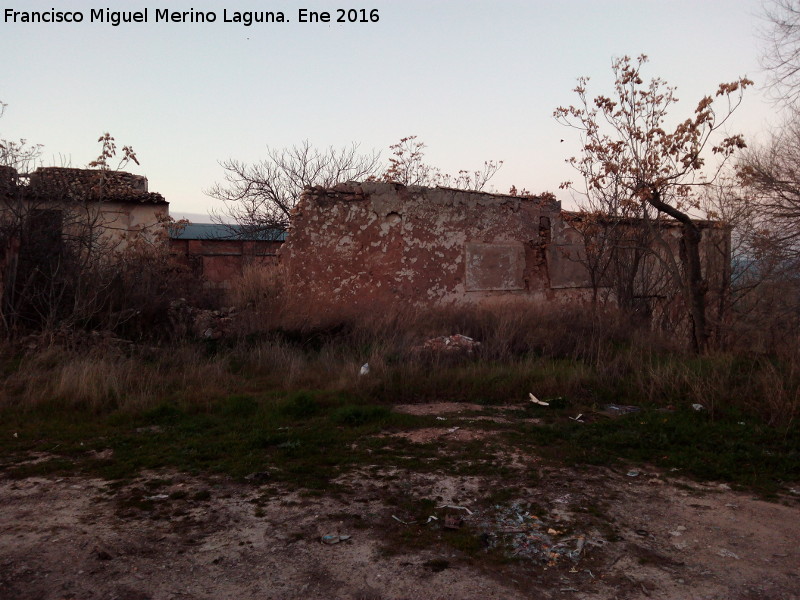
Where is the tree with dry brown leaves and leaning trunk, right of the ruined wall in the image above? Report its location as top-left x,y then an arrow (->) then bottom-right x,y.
554,55 -> 752,351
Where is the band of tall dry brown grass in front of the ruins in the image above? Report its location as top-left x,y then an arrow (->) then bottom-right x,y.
0,305 -> 800,427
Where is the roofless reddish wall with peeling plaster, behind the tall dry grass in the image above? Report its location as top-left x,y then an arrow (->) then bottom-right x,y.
280,182 -> 730,324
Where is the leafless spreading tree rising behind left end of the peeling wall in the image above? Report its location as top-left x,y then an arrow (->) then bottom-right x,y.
206,140 -> 380,237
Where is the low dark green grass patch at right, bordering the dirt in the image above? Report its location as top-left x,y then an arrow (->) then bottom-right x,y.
511,409 -> 800,494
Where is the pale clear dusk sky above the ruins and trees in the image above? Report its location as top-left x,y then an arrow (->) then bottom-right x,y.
0,0 -> 778,222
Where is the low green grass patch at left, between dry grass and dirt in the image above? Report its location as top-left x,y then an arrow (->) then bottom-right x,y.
0,392 -> 427,489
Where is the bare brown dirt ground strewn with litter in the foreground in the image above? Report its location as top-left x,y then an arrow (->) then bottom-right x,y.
0,405 -> 800,600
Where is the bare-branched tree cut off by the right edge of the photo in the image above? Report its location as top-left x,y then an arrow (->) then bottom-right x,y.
723,0 -> 800,349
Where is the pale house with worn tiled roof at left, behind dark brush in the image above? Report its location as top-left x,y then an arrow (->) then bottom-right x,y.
0,167 -> 173,331
